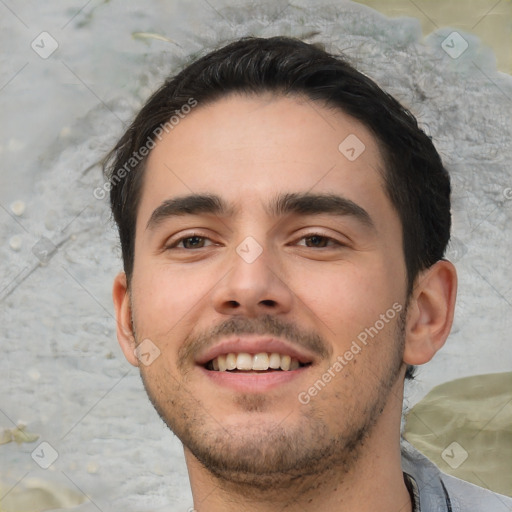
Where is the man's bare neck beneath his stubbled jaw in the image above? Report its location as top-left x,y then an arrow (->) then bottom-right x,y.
185,393 -> 412,512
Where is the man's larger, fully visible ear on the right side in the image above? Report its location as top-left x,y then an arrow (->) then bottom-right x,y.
404,260 -> 457,365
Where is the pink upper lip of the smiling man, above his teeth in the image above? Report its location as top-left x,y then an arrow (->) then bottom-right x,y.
196,335 -> 314,365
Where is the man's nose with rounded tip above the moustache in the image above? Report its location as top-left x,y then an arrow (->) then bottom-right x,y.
212,242 -> 293,317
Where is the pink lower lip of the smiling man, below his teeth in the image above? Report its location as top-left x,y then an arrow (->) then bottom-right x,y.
199,366 -> 308,393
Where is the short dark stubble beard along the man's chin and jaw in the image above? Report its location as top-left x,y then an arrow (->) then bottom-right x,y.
141,311 -> 406,491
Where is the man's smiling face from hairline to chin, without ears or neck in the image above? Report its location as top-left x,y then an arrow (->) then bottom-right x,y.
130,95 -> 406,488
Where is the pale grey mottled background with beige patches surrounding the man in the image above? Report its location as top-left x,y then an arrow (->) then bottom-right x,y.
0,0 -> 512,512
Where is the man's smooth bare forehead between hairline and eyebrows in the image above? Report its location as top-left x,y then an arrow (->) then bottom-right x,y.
137,94 -> 391,229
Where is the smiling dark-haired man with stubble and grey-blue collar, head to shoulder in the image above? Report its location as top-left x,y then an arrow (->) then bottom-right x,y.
106,37 -> 512,512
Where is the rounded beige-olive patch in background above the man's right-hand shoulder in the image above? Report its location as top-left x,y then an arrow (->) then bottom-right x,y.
404,372 -> 512,496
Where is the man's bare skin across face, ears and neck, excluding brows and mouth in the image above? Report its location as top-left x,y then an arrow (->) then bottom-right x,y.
113,95 -> 456,512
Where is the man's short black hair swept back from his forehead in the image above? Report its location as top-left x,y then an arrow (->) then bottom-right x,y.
104,37 -> 451,377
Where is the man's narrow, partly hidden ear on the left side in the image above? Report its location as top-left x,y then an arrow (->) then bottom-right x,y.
112,272 -> 139,366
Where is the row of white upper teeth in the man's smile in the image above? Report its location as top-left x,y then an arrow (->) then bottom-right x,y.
211,352 -> 300,372
